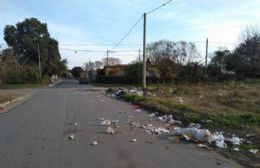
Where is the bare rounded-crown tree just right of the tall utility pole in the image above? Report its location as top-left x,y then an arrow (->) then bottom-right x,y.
147,40 -> 200,81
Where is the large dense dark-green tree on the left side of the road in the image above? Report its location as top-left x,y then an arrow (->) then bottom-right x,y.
4,18 -> 64,76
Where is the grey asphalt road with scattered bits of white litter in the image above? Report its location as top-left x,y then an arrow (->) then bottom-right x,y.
0,81 -> 244,168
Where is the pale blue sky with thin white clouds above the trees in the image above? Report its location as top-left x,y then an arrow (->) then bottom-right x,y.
0,0 -> 260,68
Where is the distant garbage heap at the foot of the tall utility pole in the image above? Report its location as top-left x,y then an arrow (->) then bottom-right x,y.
106,88 -> 144,99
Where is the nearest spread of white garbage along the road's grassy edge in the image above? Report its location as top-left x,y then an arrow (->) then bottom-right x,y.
152,113 -> 258,154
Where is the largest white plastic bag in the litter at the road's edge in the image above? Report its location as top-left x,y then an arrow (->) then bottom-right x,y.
175,128 -> 213,142
